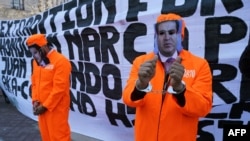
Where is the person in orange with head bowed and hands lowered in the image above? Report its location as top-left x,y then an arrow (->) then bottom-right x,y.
26,34 -> 71,141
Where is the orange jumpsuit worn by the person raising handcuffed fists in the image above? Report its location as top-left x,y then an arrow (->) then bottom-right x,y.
123,50 -> 212,141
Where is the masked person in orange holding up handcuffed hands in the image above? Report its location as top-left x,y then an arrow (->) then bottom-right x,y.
122,13 -> 212,141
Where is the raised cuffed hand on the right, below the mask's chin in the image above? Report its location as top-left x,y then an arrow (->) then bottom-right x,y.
169,56 -> 184,91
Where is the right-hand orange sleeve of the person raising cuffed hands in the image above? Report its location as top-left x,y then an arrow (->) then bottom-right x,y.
181,60 -> 212,117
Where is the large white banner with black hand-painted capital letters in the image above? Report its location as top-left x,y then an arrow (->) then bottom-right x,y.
0,0 -> 250,141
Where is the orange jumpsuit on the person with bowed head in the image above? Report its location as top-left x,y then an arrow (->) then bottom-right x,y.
31,50 -> 71,141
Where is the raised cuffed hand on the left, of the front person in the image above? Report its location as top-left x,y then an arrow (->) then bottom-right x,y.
136,55 -> 158,89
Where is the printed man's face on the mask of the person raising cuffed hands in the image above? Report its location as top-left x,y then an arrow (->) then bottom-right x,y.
157,21 -> 177,57
